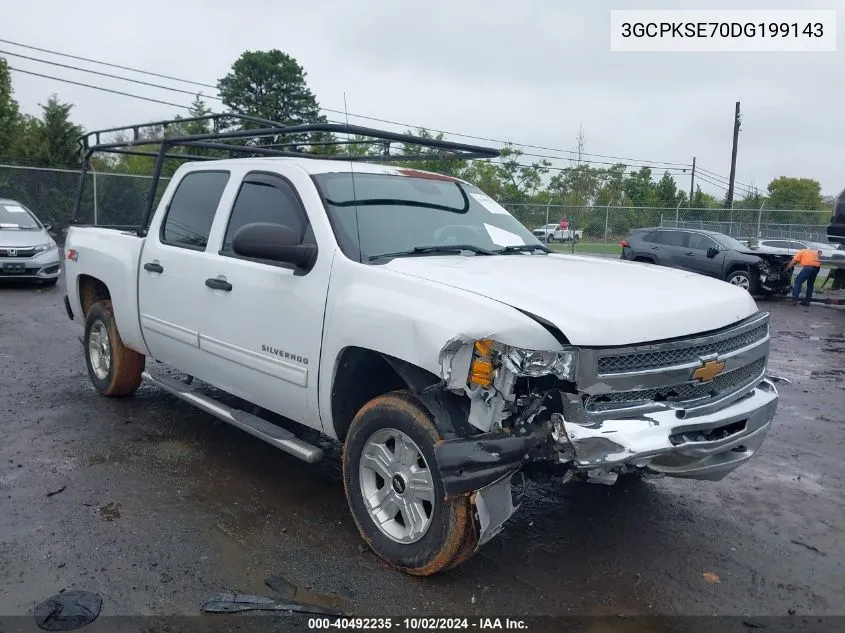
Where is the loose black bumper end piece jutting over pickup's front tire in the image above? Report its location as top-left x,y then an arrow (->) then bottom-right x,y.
434,430 -> 556,497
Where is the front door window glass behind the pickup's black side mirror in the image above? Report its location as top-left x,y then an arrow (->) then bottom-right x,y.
220,174 -> 308,256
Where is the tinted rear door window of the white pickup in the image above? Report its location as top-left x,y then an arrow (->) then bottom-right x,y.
161,171 -> 229,251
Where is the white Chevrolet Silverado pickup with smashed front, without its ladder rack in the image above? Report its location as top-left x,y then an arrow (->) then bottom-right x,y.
64,119 -> 778,575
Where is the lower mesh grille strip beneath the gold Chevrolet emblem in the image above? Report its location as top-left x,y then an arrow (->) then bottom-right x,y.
584,357 -> 766,411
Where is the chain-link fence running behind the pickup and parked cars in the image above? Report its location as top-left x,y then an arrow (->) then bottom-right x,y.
0,165 -> 830,242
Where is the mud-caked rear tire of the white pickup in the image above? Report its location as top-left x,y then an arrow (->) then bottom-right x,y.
83,301 -> 146,396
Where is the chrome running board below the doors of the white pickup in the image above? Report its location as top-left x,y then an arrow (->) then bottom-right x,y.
141,371 -> 323,464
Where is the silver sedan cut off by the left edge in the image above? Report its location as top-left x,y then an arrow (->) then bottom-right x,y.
0,198 -> 61,286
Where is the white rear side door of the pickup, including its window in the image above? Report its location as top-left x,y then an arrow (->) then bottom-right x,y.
138,170 -> 229,378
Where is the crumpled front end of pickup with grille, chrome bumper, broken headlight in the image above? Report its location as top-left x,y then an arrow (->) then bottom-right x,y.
427,313 -> 778,547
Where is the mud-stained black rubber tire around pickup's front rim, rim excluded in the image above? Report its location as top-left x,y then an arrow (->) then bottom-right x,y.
343,391 -> 478,576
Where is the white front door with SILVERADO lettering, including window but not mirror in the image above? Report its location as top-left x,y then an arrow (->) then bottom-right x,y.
200,171 -> 332,427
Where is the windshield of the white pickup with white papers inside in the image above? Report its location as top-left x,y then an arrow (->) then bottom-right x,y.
314,170 -> 543,262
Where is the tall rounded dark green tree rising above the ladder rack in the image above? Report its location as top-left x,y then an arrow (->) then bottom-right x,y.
217,49 -> 326,145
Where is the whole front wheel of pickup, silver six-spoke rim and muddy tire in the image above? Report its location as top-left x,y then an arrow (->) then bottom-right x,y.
343,391 -> 477,576
